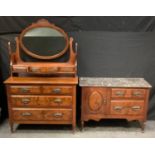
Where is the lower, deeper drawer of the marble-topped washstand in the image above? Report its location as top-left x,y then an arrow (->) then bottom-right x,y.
110,100 -> 144,115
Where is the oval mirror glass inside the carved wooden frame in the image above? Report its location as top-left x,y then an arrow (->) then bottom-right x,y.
22,27 -> 66,56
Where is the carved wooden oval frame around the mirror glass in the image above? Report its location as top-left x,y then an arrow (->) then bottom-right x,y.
19,19 -> 69,60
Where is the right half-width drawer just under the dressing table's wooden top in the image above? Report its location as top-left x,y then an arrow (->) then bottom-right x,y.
43,86 -> 73,95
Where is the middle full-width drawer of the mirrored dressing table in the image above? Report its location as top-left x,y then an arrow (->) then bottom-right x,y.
11,95 -> 72,108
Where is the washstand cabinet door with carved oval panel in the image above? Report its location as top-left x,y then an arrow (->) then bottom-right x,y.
82,87 -> 107,114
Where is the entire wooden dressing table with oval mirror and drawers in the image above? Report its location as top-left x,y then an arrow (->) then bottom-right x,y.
4,19 -> 78,132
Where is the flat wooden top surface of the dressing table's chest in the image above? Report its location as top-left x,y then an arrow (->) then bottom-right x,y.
4,77 -> 78,85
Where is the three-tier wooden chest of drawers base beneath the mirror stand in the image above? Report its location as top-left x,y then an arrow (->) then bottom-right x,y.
5,77 -> 78,132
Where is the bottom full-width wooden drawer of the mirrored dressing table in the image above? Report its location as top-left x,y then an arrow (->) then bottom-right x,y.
12,109 -> 72,121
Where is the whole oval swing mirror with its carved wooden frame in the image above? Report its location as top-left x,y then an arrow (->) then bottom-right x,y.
20,20 -> 68,60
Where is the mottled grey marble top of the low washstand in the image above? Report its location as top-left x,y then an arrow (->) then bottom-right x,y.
79,77 -> 152,88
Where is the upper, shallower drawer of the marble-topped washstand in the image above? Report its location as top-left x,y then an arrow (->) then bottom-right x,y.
111,88 -> 146,98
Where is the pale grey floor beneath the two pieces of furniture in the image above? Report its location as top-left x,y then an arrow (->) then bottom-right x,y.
0,120 -> 155,138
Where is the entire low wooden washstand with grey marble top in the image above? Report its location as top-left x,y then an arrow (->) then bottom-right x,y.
79,78 -> 151,130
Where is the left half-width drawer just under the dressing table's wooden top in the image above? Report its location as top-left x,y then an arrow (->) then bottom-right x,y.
10,85 -> 41,94
